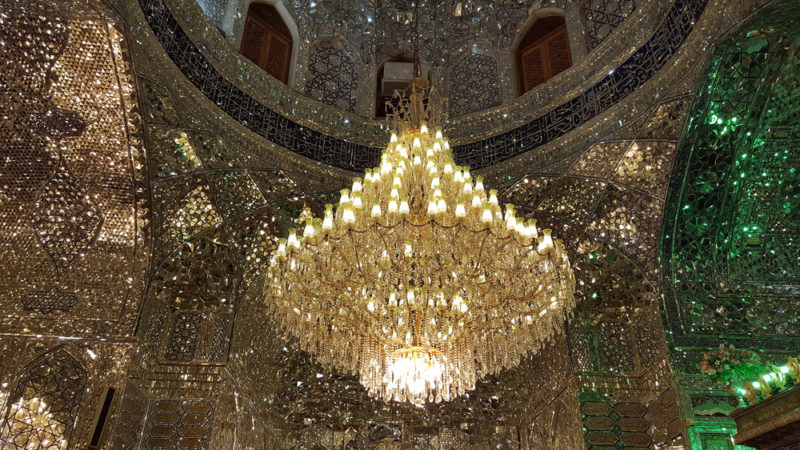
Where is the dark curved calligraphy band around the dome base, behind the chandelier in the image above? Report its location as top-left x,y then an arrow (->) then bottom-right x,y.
139,0 -> 708,171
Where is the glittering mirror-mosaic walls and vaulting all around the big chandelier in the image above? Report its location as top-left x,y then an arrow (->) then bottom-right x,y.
0,0 -> 800,449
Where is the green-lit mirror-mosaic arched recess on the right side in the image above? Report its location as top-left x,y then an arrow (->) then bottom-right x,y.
661,2 -> 800,349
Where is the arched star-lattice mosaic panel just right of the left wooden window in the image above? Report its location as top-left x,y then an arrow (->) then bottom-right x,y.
306,41 -> 358,112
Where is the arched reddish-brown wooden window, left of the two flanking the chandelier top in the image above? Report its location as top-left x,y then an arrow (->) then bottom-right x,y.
239,3 -> 293,84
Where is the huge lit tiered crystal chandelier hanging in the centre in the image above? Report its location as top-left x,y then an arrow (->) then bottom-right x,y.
264,78 -> 575,406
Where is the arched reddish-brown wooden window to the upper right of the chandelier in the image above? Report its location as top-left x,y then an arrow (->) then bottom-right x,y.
516,16 -> 572,95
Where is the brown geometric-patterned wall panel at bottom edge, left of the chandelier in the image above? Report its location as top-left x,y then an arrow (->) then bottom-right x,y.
144,399 -> 214,450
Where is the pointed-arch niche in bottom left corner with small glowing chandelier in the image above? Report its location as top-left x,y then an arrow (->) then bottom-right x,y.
0,350 -> 86,450
